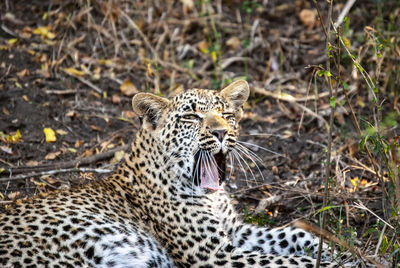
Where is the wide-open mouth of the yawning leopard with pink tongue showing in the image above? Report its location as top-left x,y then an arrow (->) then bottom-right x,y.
193,150 -> 226,191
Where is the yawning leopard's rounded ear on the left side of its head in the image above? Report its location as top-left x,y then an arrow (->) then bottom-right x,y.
132,93 -> 169,129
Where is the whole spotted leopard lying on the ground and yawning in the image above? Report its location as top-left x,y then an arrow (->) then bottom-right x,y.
0,80 -> 336,268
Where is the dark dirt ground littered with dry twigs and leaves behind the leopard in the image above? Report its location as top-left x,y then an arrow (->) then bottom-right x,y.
0,0 -> 400,266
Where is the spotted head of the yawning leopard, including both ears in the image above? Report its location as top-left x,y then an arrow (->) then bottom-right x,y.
132,80 -> 249,190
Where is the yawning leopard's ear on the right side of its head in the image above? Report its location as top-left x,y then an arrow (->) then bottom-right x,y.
221,80 -> 250,108
